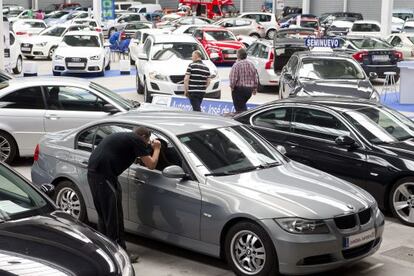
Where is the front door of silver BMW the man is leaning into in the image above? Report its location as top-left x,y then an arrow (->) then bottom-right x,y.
129,129 -> 201,239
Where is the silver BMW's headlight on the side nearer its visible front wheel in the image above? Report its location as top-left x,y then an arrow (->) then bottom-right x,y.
275,218 -> 329,234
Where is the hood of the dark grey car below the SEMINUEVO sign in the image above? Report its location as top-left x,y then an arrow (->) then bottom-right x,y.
297,80 -> 374,99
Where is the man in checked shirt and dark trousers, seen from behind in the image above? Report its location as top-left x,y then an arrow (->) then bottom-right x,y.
230,48 -> 259,113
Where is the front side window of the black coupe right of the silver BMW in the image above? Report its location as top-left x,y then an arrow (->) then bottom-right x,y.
292,107 -> 350,141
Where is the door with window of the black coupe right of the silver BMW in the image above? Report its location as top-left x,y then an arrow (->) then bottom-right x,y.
286,106 -> 367,186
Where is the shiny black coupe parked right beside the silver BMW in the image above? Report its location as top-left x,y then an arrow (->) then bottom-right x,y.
235,98 -> 414,226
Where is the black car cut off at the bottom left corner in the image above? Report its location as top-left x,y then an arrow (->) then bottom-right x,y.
0,163 -> 134,276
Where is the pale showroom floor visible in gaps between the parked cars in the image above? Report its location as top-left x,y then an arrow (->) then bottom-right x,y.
8,61 -> 414,276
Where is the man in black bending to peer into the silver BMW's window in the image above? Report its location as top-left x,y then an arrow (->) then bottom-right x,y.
88,127 -> 161,262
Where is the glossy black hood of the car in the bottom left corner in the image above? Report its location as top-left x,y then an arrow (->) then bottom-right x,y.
0,211 -> 119,276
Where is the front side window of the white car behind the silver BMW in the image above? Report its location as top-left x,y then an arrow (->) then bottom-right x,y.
45,86 -> 107,111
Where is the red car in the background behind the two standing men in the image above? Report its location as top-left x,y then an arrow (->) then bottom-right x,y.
193,27 -> 244,63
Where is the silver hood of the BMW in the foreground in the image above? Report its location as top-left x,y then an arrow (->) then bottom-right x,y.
211,161 -> 375,219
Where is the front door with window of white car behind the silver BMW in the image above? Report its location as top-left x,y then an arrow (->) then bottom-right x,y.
43,85 -> 109,132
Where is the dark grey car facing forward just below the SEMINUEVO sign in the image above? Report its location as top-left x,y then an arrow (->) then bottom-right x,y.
279,51 -> 379,101
